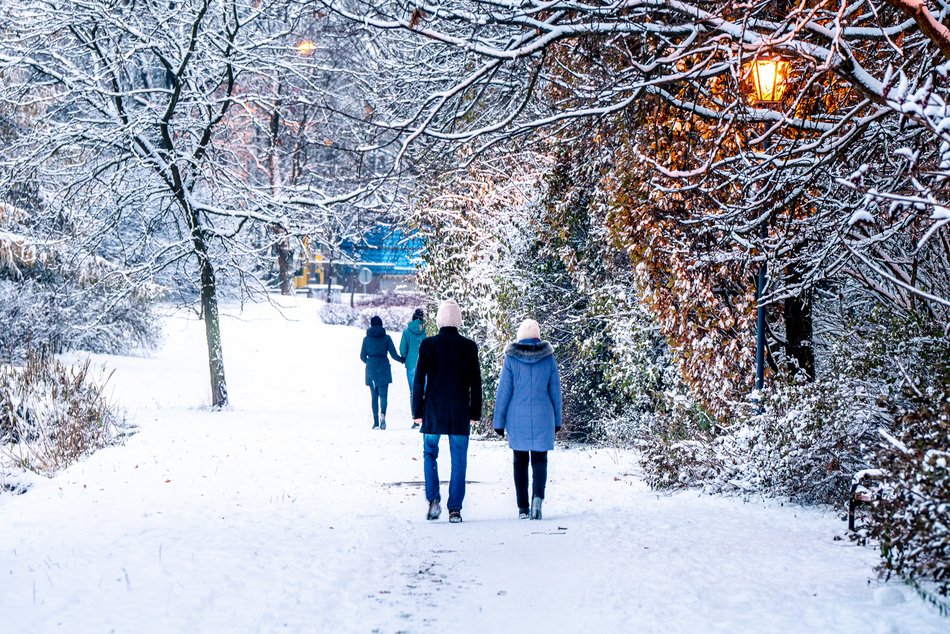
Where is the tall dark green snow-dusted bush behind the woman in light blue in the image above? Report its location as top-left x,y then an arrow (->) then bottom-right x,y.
499,145 -> 669,440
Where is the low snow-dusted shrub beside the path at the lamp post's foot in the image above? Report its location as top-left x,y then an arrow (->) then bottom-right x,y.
640,370 -> 887,504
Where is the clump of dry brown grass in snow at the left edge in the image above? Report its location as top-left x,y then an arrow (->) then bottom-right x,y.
0,354 -> 122,475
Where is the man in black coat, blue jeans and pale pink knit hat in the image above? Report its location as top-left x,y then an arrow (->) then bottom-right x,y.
412,299 -> 482,523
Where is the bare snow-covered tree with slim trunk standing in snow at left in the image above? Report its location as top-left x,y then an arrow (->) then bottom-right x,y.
0,0 -> 388,406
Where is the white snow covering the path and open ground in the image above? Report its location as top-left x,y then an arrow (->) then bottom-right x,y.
0,300 -> 948,634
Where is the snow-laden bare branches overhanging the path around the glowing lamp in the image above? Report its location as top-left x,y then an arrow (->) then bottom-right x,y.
324,0 -> 950,306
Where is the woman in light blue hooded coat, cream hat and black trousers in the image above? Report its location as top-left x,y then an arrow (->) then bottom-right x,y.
492,319 -> 561,520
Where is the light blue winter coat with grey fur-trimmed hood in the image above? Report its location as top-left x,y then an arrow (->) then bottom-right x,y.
493,339 -> 561,451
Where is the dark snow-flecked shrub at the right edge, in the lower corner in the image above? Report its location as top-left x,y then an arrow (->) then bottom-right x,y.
858,393 -> 950,613
